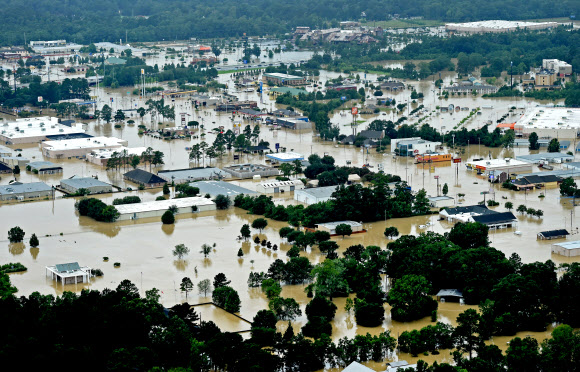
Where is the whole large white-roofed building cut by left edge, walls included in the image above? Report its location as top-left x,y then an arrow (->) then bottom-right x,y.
0,116 -> 85,145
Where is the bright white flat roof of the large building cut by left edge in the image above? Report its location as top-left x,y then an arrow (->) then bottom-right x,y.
0,116 -> 85,138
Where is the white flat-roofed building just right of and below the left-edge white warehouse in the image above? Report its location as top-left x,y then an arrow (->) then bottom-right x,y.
41,137 -> 127,159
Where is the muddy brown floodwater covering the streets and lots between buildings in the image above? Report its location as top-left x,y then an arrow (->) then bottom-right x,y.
0,61 -> 580,370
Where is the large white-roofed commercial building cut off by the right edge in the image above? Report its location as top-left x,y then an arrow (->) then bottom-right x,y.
514,107 -> 580,139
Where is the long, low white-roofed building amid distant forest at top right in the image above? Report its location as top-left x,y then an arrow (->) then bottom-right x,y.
445,20 -> 558,34
